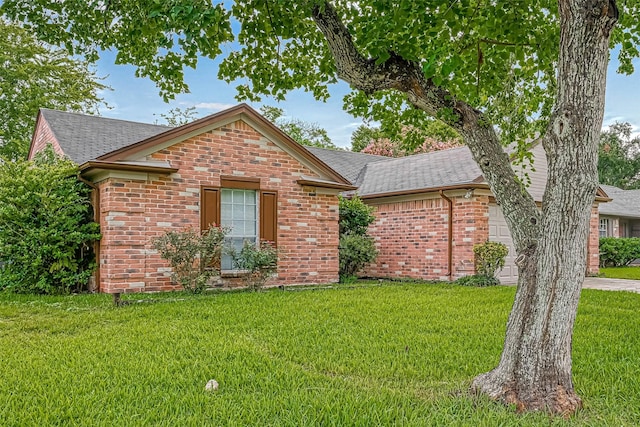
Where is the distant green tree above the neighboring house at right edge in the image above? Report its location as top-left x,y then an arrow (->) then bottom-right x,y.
598,123 -> 640,190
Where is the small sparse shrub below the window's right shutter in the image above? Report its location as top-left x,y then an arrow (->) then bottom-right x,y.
229,240 -> 278,291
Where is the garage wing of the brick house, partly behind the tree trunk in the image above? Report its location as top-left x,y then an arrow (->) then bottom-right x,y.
310,144 -> 609,283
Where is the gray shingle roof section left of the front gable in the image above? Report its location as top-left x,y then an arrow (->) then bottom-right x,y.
40,108 -> 171,164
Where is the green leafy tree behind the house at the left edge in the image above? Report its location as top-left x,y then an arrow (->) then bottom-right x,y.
0,19 -> 106,161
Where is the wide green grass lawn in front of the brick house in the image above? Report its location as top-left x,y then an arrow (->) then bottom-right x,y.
0,284 -> 640,426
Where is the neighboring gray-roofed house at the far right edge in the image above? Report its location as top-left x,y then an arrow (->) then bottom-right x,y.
599,185 -> 640,237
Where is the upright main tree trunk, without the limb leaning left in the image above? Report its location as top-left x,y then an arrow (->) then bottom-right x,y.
472,0 -> 617,415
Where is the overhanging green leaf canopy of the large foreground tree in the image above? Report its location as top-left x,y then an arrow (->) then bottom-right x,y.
2,0 -> 640,142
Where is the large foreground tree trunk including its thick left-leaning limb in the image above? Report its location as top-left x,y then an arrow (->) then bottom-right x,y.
313,0 -> 617,414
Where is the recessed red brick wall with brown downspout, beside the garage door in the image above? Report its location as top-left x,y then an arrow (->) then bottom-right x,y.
363,195 -> 489,280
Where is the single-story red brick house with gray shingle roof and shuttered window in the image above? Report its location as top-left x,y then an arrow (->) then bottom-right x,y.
30,104 -> 609,293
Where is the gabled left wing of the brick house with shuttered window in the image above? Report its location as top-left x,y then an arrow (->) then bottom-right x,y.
29,104 -> 355,293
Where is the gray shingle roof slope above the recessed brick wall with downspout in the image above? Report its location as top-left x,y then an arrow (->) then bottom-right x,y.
352,147 -> 482,196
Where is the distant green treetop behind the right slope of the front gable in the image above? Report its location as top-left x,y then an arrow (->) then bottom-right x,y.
260,105 -> 340,150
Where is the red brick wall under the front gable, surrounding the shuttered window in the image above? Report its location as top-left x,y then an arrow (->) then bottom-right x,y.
99,122 -> 338,292
